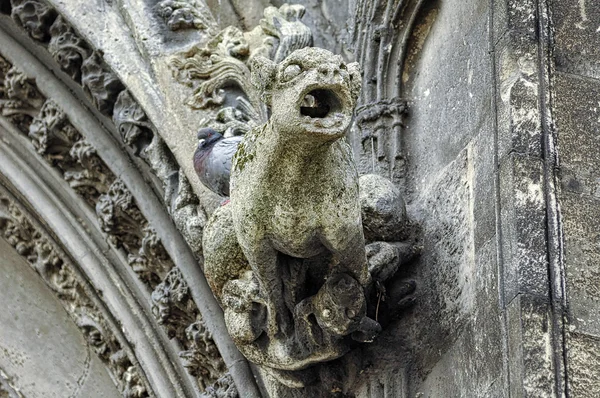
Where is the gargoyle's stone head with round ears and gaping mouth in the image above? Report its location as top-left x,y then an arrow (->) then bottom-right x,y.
251,47 -> 361,140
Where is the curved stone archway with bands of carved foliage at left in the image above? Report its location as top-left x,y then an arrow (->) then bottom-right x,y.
0,1 -> 256,396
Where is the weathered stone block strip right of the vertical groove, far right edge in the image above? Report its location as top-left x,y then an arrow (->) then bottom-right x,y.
551,1 -> 600,397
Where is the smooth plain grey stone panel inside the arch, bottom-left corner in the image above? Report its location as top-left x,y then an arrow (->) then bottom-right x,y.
0,238 -> 121,398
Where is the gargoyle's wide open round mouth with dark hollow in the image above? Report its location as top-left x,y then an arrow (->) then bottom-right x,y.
300,88 -> 346,129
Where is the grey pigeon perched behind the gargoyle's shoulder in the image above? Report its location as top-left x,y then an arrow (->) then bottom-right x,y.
194,127 -> 243,197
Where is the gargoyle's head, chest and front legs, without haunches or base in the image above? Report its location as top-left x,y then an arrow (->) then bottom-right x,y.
231,48 -> 369,334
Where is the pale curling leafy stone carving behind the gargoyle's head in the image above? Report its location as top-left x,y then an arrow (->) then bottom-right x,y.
172,4 -> 312,137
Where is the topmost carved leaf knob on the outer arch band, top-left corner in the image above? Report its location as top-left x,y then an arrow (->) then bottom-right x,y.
11,0 -> 56,41
